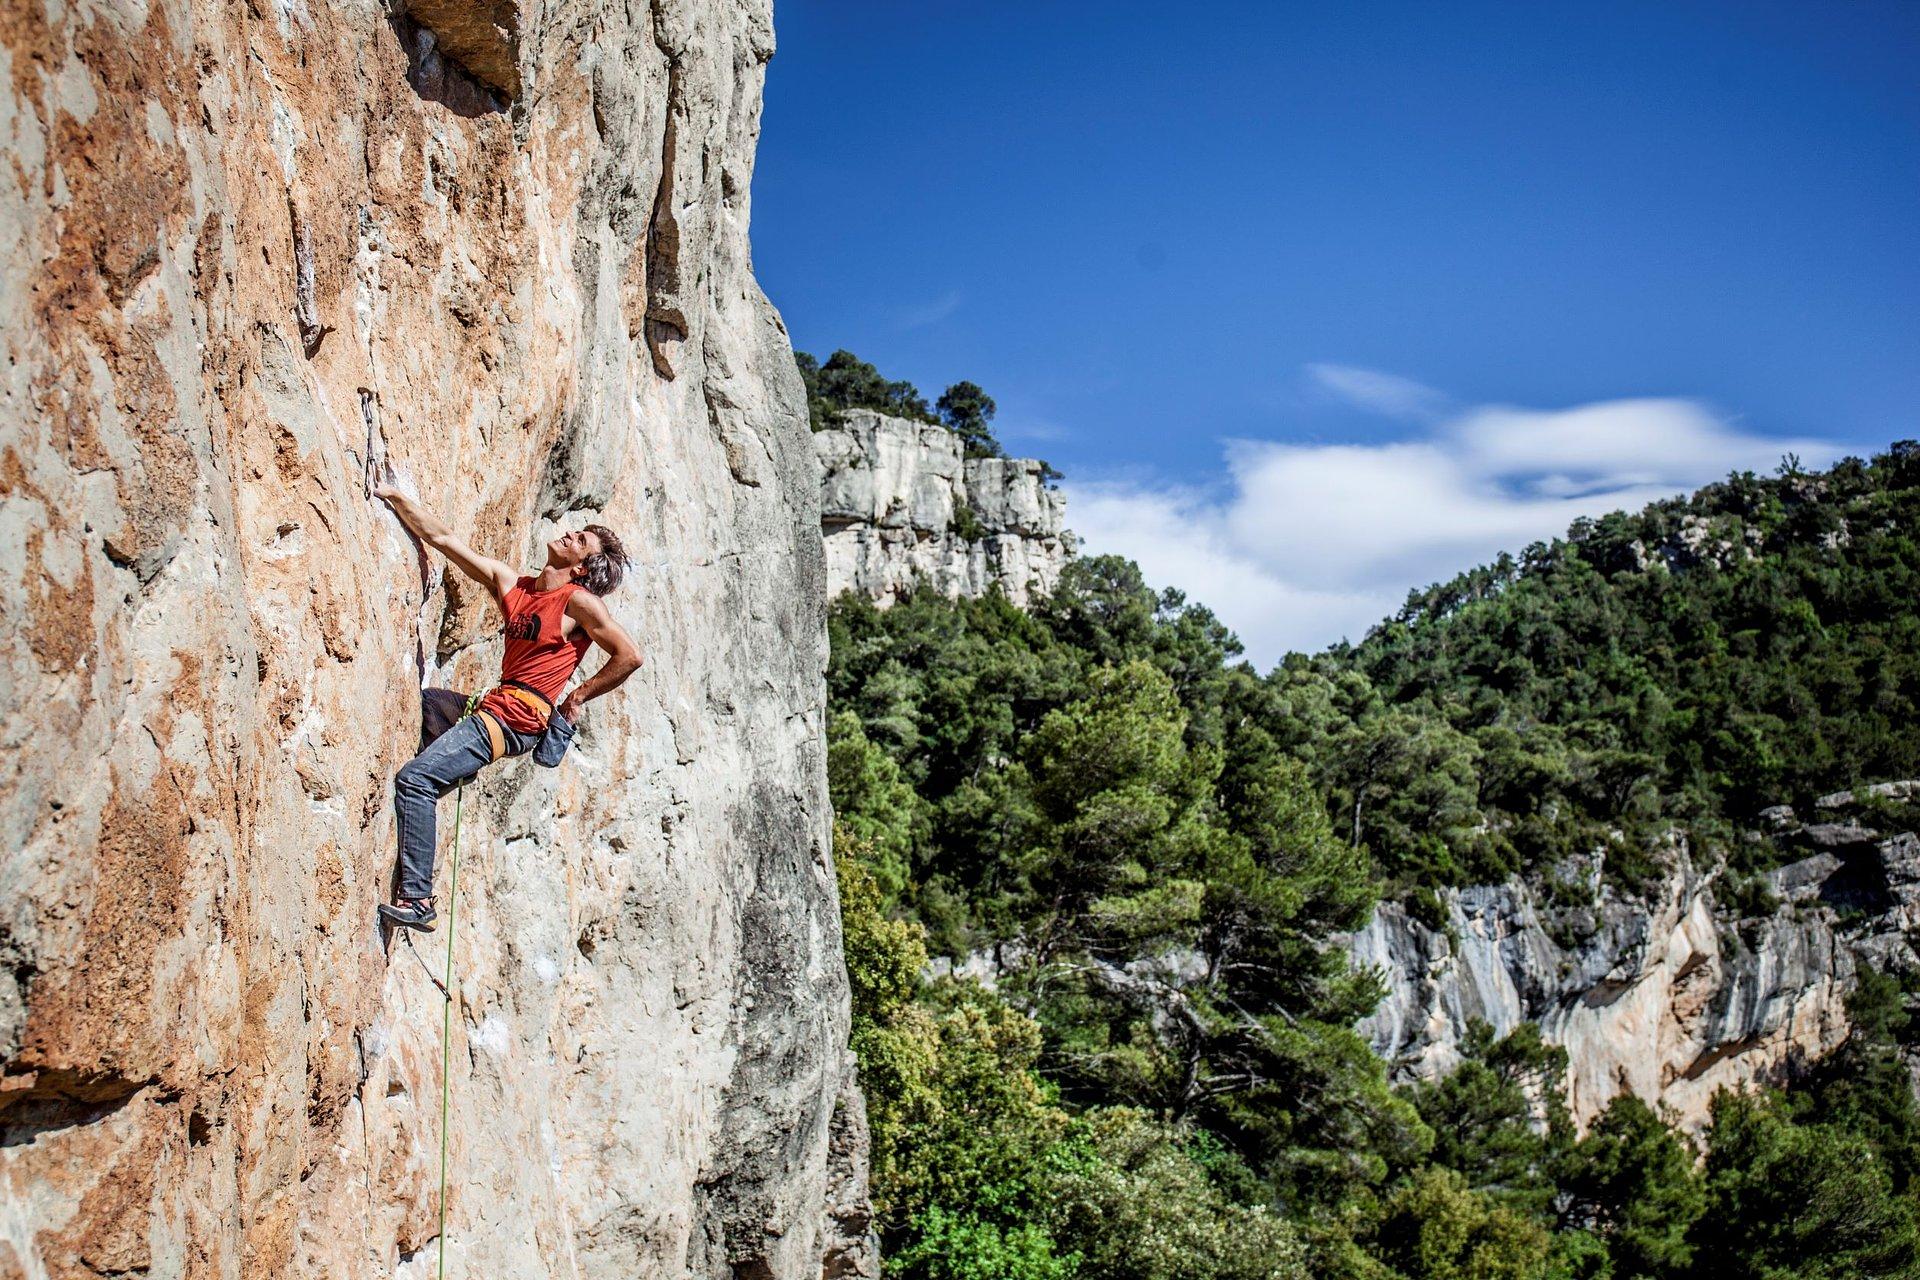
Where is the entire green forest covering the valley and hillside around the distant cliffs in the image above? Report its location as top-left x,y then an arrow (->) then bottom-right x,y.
808,418 -> 1920,1280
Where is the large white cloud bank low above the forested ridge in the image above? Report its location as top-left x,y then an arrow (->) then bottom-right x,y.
1066,383 -> 1837,670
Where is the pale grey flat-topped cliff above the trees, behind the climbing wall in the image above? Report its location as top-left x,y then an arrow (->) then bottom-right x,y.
814,409 -> 1073,604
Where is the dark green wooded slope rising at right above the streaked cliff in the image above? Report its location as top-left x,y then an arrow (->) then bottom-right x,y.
1351,441 -> 1920,898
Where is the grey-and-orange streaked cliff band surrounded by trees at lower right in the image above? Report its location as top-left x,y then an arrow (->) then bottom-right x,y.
1352,793 -> 1920,1126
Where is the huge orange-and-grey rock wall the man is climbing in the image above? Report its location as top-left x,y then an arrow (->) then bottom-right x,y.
0,0 -> 860,1280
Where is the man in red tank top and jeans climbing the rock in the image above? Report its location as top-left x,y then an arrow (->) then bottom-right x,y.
374,486 -> 639,929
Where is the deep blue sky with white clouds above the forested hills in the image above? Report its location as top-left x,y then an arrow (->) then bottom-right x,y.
753,0 -> 1920,664
